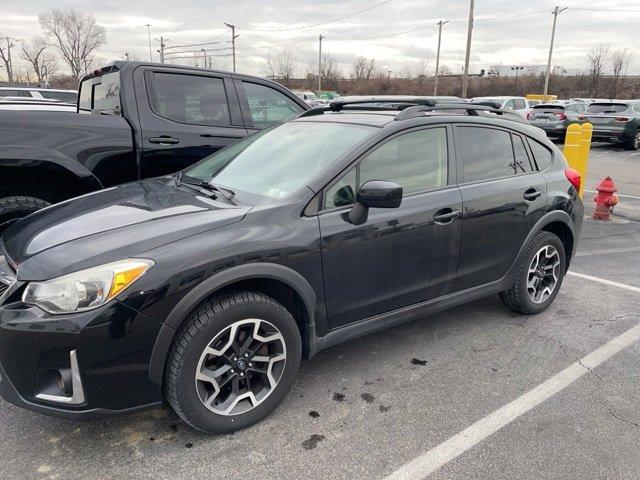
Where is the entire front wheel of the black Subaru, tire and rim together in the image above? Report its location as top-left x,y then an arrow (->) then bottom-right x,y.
165,292 -> 302,433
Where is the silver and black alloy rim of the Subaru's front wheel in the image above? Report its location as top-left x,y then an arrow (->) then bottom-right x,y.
195,319 -> 287,415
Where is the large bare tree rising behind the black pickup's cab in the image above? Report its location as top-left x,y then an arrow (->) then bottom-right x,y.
38,10 -> 106,77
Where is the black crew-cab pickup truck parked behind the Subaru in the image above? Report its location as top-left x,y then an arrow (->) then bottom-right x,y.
0,62 -> 309,233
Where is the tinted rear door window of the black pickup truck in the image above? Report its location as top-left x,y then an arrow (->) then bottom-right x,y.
150,72 -> 231,126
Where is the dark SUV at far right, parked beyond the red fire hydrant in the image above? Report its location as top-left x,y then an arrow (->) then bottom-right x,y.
578,100 -> 640,150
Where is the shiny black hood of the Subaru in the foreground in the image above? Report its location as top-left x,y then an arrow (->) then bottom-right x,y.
2,177 -> 251,280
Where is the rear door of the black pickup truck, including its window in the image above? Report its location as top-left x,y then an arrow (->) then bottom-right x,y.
134,67 -> 247,178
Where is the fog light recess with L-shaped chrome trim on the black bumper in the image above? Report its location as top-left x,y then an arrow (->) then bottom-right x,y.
36,350 -> 84,405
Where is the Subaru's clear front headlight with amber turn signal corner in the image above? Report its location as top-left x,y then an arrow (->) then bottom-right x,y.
22,258 -> 153,313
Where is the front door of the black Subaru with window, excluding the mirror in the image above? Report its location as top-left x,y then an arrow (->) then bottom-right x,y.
319,127 -> 462,328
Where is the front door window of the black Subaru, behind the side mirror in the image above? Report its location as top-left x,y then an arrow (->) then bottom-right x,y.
324,128 -> 448,208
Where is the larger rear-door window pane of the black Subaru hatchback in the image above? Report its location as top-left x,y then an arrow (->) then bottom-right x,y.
458,127 -> 515,182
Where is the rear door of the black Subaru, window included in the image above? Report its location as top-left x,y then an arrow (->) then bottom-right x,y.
455,124 -> 547,290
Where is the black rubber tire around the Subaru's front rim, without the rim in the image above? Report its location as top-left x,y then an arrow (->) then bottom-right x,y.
164,292 -> 302,433
